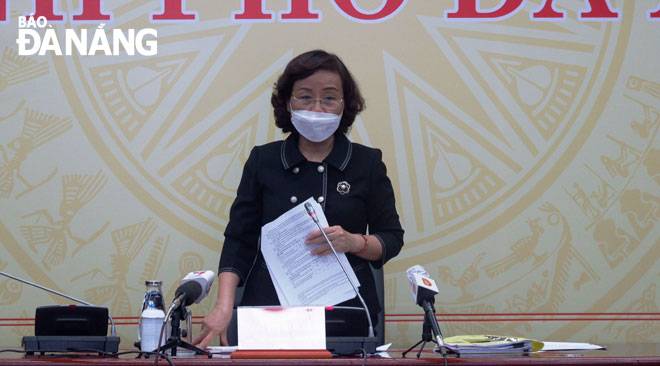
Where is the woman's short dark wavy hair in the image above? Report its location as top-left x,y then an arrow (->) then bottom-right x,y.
270,50 -> 365,134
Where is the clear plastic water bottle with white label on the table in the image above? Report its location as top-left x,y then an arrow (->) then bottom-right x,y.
138,281 -> 166,352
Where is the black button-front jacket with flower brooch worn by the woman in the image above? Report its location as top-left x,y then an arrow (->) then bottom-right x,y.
219,134 -> 403,321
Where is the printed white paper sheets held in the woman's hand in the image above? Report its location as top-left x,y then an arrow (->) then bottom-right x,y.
261,197 -> 360,306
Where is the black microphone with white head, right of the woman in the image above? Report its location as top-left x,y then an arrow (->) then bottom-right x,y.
406,264 -> 447,358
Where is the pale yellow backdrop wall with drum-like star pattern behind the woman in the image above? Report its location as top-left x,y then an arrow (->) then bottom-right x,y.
0,0 -> 660,349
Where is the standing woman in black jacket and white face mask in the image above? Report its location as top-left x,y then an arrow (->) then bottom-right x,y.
193,50 -> 403,348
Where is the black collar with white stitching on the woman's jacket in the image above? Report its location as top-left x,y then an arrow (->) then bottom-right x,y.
280,133 -> 353,171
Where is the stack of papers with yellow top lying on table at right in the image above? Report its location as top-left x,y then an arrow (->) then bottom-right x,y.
444,335 -> 543,354
